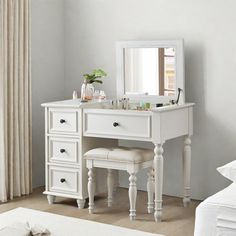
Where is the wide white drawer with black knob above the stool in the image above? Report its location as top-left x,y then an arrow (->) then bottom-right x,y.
84,109 -> 151,140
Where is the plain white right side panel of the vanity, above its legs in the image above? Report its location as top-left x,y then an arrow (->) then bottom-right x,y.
161,108 -> 189,140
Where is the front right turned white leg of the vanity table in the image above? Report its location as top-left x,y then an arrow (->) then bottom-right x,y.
154,144 -> 164,222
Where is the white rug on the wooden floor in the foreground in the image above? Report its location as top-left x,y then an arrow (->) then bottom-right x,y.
0,208 -> 163,236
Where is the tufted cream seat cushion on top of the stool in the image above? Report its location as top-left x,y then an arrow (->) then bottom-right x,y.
84,147 -> 154,164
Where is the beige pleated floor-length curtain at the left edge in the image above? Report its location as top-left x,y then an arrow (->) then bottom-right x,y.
0,0 -> 32,202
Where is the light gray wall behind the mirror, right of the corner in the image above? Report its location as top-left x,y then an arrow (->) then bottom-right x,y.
65,0 -> 236,199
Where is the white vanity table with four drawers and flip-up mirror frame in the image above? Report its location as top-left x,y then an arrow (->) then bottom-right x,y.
42,41 -> 194,221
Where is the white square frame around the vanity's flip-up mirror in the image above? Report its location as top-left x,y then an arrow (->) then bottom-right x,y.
116,39 -> 185,103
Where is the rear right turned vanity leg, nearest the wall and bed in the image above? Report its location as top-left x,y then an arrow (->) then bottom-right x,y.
183,136 -> 191,207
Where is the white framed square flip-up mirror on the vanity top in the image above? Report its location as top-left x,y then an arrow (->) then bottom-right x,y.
116,40 -> 185,103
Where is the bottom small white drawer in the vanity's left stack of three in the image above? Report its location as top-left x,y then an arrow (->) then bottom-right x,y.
49,166 -> 79,193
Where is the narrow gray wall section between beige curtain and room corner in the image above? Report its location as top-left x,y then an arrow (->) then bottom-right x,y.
32,0 -> 65,187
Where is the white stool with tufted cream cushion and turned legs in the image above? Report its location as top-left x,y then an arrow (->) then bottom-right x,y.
84,147 -> 154,220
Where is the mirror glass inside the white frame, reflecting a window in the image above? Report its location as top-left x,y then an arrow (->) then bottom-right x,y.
123,47 -> 176,96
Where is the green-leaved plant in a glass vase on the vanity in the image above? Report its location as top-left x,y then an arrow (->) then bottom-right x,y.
81,69 -> 107,101
